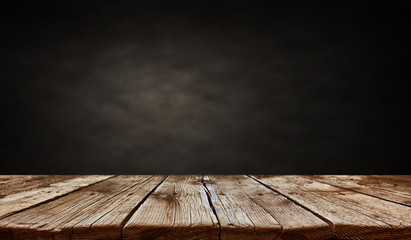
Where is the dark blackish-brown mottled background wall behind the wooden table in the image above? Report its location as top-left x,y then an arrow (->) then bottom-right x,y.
0,0 -> 411,174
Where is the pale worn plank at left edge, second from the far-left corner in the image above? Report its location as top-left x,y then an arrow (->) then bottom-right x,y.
0,175 -> 111,221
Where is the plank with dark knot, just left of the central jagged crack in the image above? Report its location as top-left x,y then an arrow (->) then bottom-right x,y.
123,176 -> 219,240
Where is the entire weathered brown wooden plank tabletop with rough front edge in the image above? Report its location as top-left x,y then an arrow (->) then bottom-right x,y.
0,175 -> 411,240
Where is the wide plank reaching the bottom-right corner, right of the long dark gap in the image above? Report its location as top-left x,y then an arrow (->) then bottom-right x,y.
257,176 -> 411,239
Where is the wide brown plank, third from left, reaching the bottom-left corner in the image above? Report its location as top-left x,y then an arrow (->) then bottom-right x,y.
0,176 -> 165,239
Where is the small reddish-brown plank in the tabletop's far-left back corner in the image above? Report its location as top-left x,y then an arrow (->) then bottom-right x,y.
0,175 -> 79,198
